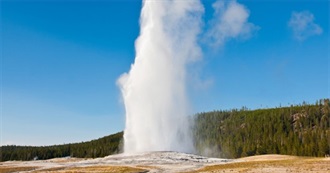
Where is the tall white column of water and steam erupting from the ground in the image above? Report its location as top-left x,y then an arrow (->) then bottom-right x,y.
118,0 -> 204,153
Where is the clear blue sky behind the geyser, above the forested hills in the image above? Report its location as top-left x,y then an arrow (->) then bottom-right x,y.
1,0 -> 330,145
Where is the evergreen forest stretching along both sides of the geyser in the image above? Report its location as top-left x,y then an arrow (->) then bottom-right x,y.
0,99 -> 330,161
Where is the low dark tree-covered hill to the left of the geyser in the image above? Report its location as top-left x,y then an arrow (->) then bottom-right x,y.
0,132 -> 123,161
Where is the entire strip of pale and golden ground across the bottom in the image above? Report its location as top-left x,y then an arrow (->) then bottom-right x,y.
0,152 -> 330,173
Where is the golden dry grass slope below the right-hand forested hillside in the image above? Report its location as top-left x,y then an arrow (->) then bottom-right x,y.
183,156 -> 330,173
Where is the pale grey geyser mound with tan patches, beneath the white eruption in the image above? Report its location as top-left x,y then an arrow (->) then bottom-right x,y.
0,151 -> 232,173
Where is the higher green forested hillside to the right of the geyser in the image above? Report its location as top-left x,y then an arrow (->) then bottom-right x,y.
194,99 -> 330,158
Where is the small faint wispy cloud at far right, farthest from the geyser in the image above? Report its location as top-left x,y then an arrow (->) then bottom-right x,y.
288,11 -> 323,41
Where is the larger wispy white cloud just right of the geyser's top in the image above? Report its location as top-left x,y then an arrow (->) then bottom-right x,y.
206,0 -> 260,47
